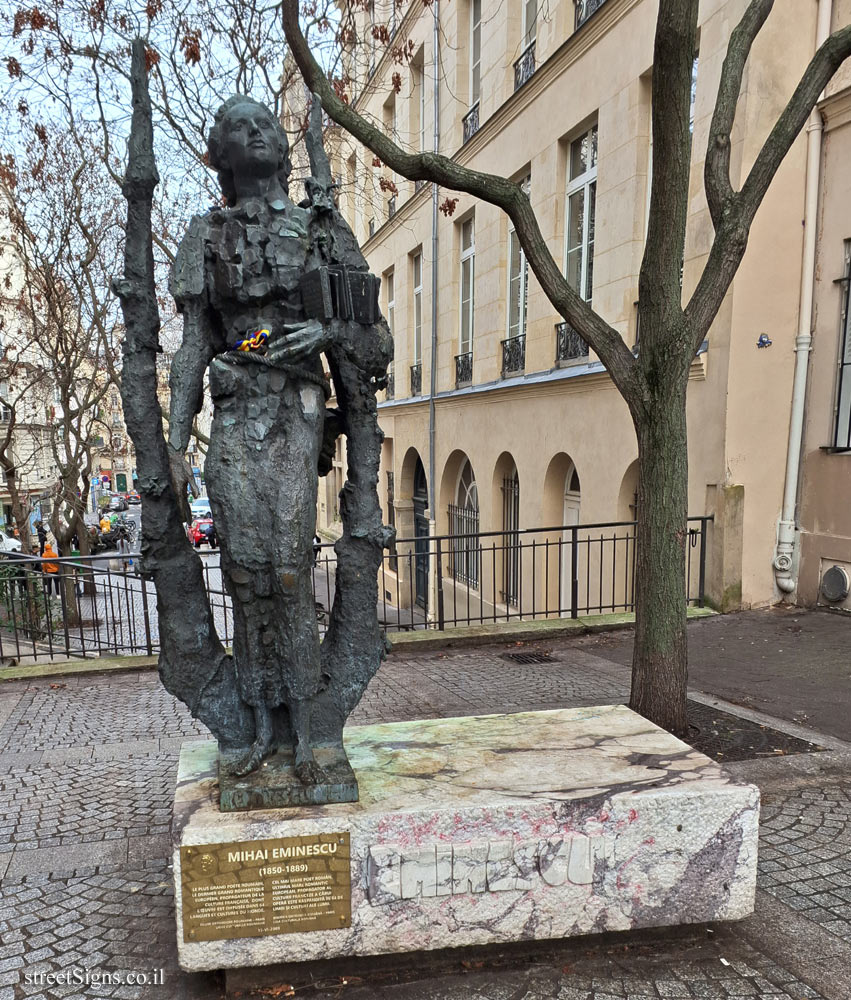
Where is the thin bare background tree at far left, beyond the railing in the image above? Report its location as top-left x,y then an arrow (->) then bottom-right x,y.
0,123 -> 123,576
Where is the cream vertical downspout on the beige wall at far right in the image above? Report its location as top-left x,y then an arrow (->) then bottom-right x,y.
774,0 -> 833,594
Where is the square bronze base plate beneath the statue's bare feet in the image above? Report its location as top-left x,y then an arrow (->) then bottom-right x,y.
219,746 -> 358,812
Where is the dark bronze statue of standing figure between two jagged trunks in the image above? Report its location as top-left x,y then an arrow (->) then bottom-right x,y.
116,37 -> 392,808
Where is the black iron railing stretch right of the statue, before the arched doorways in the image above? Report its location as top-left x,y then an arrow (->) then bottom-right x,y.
348,508 -> 712,631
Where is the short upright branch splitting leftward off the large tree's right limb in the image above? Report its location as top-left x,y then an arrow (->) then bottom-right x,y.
703,0 -> 774,231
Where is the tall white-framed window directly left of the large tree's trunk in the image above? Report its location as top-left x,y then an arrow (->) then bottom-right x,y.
565,125 -> 597,302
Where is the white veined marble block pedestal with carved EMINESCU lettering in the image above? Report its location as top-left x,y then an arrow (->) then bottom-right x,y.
173,705 -> 759,971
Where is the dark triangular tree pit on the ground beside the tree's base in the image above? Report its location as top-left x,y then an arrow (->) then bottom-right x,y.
687,701 -> 824,763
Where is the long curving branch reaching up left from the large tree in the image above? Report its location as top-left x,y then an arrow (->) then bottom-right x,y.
281,0 -> 644,406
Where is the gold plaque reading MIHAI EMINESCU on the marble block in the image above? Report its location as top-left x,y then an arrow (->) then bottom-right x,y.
180,833 -> 352,941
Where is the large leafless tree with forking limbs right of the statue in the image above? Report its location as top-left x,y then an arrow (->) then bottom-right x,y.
281,0 -> 851,734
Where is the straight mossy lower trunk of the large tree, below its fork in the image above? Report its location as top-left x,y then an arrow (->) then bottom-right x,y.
629,374 -> 688,736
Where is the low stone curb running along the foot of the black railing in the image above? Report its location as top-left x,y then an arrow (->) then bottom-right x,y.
0,608 -> 718,683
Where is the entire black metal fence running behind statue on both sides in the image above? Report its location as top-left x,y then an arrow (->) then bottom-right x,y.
0,516 -> 712,664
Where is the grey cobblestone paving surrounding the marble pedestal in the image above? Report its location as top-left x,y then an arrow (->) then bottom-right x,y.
0,604 -> 851,1000
